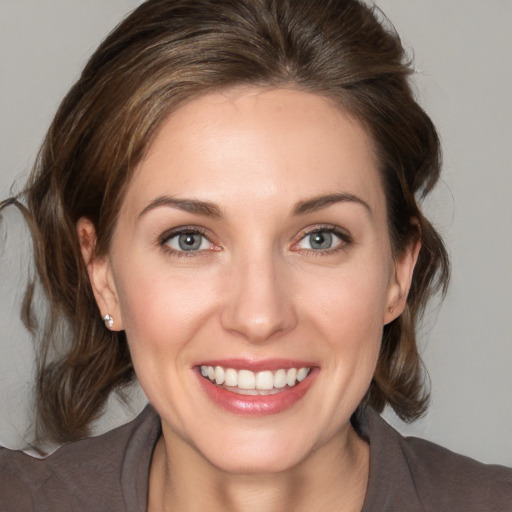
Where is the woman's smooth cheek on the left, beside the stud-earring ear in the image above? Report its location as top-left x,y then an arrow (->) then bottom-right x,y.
112,265 -> 222,412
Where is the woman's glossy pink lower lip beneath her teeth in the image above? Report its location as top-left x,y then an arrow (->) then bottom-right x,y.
198,368 -> 317,416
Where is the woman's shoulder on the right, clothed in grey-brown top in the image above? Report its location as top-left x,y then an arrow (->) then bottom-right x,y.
362,410 -> 512,512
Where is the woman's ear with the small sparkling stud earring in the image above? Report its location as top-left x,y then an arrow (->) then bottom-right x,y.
76,217 -> 123,331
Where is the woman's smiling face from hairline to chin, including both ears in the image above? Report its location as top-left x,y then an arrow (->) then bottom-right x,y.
83,89 -> 414,472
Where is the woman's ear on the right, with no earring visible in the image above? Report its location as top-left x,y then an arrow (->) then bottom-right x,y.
384,237 -> 421,325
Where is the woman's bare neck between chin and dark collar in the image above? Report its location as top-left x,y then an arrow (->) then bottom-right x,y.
148,427 -> 369,512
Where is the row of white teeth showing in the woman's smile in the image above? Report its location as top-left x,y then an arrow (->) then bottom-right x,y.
201,366 -> 311,394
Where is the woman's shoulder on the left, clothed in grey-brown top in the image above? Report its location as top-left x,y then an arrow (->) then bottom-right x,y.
0,406 -> 159,512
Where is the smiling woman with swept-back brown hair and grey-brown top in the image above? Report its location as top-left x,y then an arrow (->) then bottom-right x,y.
0,0 -> 512,511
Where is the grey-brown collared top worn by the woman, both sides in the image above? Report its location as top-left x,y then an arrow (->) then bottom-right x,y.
0,405 -> 512,512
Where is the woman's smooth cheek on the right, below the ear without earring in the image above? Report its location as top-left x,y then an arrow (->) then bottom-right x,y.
302,261 -> 388,392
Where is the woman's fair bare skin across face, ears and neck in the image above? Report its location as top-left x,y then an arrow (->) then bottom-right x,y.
77,88 -> 419,512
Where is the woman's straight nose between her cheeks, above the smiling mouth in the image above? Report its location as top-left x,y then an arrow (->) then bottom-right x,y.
221,251 -> 297,343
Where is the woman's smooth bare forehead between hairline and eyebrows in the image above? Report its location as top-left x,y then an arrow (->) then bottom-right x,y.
121,88 -> 383,219
